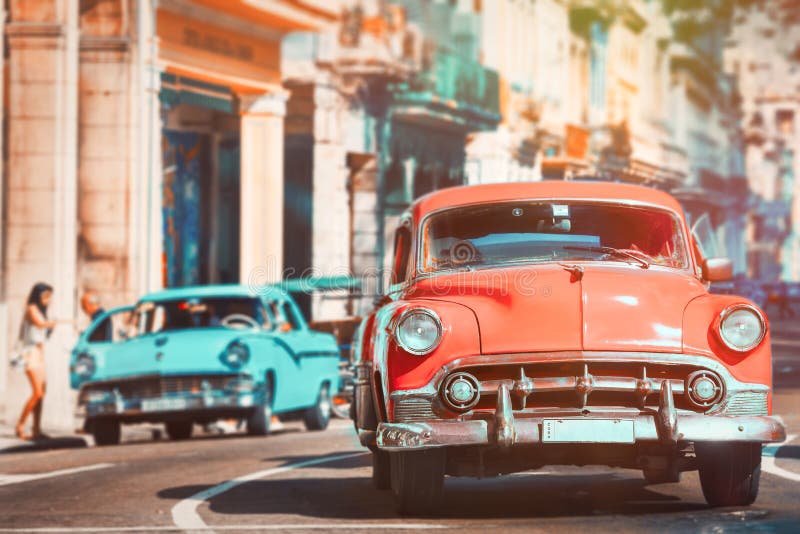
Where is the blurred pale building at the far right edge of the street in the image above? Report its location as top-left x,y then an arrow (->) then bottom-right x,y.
725,1 -> 800,281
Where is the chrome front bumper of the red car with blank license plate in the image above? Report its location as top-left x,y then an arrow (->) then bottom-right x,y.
376,381 -> 786,451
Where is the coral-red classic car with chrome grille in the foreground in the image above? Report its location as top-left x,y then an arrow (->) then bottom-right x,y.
353,181 -> 785,514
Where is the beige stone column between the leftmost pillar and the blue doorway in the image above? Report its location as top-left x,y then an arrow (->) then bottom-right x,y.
77,18 -> 137,308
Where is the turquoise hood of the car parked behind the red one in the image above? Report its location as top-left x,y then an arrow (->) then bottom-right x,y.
92,328 -> 255,380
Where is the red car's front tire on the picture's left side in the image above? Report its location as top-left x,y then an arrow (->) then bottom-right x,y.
389,449 -> 446,516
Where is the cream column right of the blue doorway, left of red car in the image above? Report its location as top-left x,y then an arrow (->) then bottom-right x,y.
239,92 -> 288,286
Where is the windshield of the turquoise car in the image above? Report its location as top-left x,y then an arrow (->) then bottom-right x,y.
136,297 -> 269,335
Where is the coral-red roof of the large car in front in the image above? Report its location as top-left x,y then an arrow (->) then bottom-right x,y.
411,180 -> 683,220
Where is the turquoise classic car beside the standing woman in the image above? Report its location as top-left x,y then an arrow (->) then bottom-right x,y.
70,285 -> 339,445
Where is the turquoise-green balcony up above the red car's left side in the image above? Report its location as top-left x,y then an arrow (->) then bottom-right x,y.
395,49 -> 502,129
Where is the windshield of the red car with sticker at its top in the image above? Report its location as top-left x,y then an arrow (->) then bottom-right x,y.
421,201 -> 688,272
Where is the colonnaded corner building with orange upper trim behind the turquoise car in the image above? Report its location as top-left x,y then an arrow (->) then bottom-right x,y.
0,0 -> 340,426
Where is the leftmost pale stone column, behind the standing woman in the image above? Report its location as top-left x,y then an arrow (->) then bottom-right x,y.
4,0 -> 78,429
